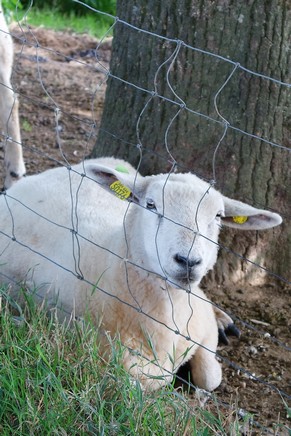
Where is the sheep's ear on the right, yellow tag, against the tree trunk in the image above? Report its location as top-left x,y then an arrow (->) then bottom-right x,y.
222,197 -> 282,230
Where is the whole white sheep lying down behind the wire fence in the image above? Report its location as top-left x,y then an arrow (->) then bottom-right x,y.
0,158 -> 282,391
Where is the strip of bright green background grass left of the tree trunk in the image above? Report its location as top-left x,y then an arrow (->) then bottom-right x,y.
14,6 -> 113,38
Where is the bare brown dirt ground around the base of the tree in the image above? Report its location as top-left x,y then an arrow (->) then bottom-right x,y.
0,26 -> 291,435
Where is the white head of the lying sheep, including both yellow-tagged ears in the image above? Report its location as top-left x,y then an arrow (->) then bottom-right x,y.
87,165 -> 282,287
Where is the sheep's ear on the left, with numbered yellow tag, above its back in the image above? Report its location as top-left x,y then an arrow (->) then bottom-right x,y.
86,164 -> 141,203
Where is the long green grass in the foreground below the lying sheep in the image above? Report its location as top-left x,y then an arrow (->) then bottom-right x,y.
0,290 -> 258,436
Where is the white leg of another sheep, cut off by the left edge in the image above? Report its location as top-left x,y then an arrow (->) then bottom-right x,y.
0,2 -> 25,188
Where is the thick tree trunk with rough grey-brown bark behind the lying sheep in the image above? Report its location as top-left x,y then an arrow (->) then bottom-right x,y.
92,0 -> 291,285
